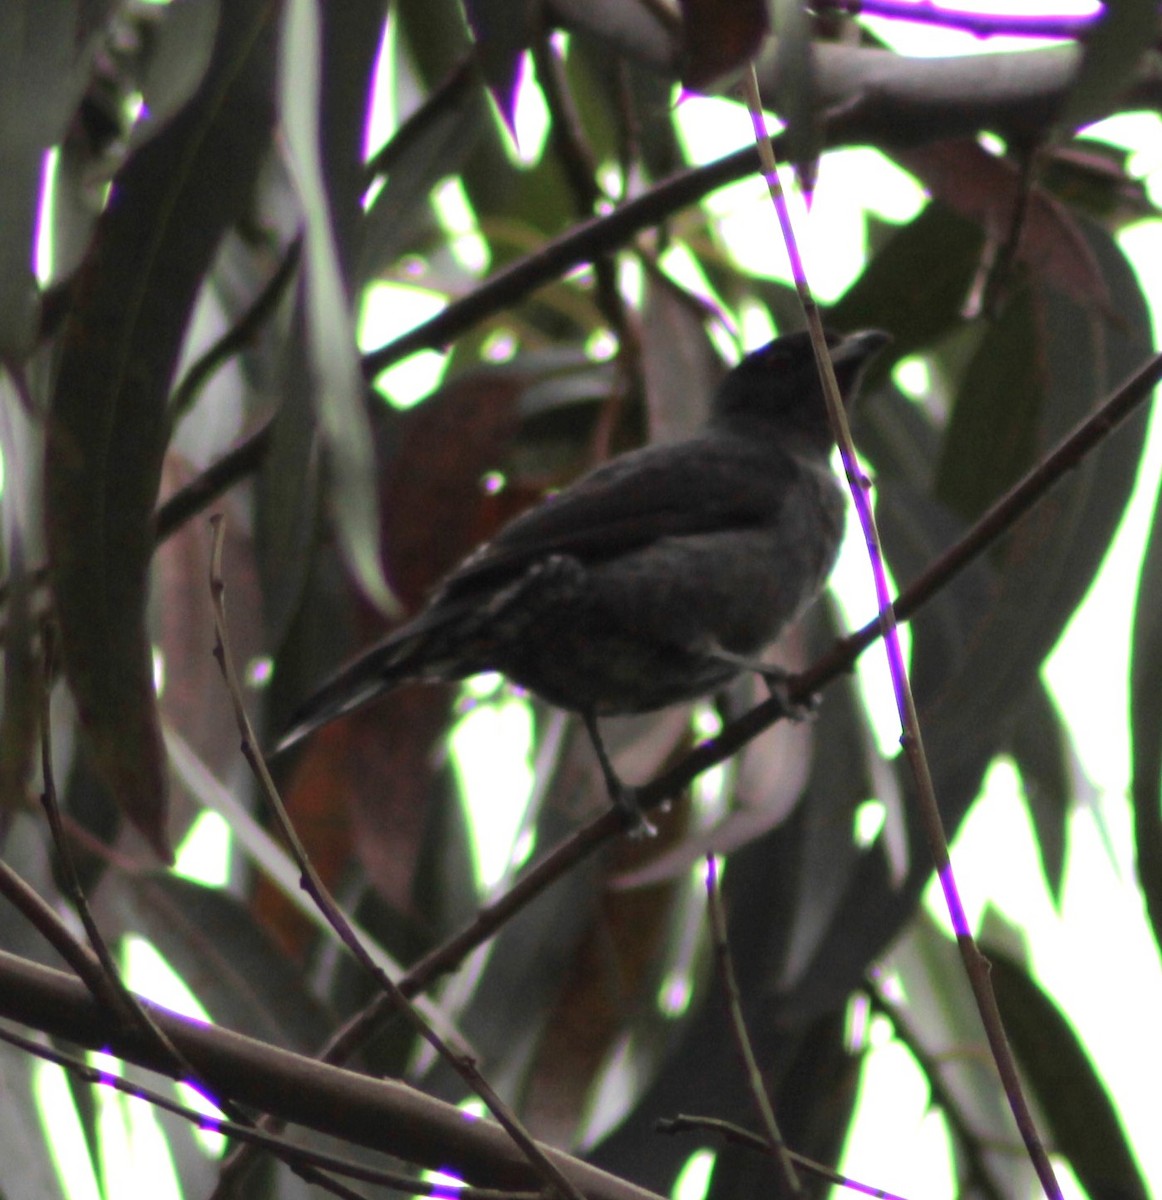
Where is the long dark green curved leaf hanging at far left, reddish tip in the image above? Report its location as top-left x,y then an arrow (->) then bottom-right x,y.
44,0 -> 272,858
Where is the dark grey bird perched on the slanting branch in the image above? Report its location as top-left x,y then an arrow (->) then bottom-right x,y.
278,330 -> 888,823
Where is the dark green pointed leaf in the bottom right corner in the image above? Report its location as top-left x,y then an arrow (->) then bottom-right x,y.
987,947 -> 1150,1200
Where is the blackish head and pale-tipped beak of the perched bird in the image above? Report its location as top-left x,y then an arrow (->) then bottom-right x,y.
711,329 -> 891,451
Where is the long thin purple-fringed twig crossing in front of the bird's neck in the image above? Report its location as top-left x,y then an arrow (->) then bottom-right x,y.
743,66 -> 1061,1200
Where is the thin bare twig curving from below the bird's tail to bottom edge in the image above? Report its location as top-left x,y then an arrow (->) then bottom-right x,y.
210,514 -> 582,1200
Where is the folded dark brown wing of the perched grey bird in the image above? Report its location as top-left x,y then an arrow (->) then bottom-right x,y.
441,436 -> 799,601
